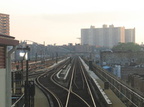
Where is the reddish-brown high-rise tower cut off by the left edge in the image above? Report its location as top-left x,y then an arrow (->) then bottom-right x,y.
0,13 -> 10,35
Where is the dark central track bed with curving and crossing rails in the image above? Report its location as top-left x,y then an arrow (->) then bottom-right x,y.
37,57 -> 101,107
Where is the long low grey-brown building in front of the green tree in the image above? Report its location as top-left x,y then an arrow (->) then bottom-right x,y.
100,51 -> 144,66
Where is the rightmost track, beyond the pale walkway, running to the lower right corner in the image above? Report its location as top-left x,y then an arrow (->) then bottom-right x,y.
85,60 -> 144,107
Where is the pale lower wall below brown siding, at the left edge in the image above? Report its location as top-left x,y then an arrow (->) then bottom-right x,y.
0,69 -> 6,107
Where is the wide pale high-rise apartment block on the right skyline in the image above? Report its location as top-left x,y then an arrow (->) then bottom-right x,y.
81,25 -> 135,48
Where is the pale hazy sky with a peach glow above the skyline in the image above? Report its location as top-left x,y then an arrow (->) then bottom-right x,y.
0,0 -> 144,45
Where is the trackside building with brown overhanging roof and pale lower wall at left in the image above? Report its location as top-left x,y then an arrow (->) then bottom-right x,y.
0,34 -> 19,107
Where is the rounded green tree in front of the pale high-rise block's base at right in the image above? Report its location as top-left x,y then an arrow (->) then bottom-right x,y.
112,42 -> 141,51
